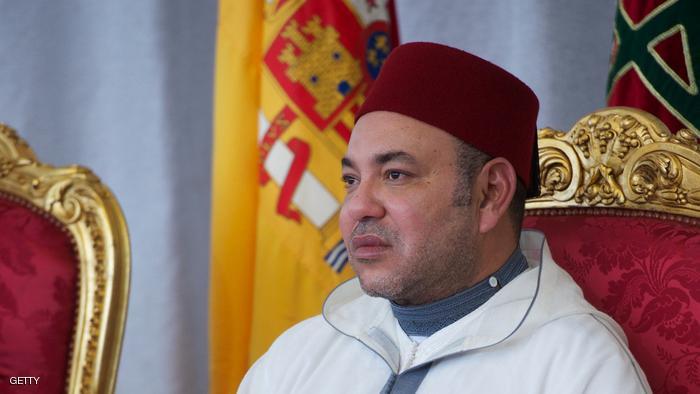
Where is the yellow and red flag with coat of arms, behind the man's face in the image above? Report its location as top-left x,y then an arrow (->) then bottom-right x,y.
210,0 -> 396,393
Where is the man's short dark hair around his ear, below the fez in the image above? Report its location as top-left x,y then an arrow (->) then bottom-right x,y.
453,140 -> 527,237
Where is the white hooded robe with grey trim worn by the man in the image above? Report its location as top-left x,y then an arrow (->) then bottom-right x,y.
238,231 -> 651,394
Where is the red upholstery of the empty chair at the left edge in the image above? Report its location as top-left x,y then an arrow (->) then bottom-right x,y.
0,195 -> 78,393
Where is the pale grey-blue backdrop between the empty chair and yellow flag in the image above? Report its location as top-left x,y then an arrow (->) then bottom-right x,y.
0,0 -> 217,393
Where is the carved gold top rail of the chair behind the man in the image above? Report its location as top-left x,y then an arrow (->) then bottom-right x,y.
526,107 -> 700,226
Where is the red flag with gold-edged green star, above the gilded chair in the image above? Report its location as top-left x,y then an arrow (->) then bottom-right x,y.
608,0 -> 700,136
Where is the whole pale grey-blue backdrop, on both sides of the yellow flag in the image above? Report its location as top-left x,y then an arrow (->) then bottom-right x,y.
0,0 -> 615,393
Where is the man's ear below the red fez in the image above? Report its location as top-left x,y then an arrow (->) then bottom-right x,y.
474,157 -> 517,234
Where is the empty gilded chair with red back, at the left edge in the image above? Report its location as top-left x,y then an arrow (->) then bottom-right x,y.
0,124 -> 130,393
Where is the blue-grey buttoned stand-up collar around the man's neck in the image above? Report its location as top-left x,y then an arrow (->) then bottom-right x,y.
391,247 -> 528,337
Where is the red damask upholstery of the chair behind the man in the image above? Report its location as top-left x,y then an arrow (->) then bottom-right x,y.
525,216 -> 700,394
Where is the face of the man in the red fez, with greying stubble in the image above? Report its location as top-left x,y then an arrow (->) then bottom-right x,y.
340,112 -> 477,304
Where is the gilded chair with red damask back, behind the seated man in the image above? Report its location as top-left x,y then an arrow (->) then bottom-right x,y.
524,107 -> 700,393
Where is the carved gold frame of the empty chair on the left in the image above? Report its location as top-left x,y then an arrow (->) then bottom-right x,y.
0,124 -> 130,393
